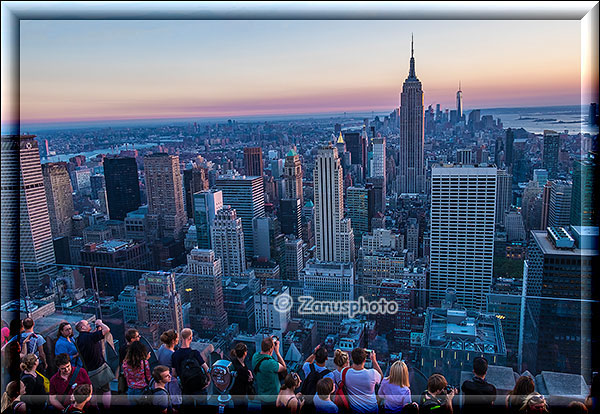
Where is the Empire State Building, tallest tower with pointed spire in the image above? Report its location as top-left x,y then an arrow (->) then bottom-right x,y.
397,36 -> 425,194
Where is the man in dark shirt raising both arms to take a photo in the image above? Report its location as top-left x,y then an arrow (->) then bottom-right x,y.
75,319 -> 115,410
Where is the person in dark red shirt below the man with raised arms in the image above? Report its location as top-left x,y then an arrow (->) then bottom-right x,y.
49,353 -> 92,411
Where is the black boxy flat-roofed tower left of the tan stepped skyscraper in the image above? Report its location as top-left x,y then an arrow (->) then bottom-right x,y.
103,156 -> 142,220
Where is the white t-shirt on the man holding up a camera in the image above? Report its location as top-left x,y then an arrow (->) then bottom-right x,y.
345,368 -> 381,413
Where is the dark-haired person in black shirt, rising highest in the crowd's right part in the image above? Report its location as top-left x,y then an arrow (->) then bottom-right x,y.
461,357 -> 497,414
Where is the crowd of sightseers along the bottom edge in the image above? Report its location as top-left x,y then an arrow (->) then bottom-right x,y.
0,318 -> 598,414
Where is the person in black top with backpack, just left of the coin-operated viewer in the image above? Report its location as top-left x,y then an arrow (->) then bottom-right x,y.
171,328 -> 214,405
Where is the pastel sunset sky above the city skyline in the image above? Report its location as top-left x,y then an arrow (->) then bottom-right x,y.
20,20 -> 581,123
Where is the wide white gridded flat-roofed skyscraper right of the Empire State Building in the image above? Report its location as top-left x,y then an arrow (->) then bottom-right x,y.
429,166 -> 497,309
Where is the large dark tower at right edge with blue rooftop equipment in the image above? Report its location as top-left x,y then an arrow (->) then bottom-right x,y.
521,227 -> 598,376
